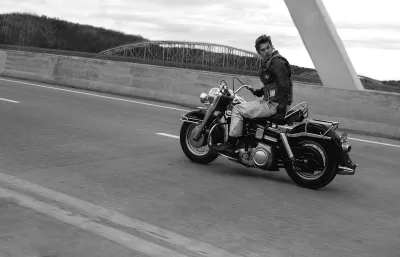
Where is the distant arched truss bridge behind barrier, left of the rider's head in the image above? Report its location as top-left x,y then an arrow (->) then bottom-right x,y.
100,41 -> 261,71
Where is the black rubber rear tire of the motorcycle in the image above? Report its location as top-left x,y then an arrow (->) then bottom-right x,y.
285,138 -> 338,190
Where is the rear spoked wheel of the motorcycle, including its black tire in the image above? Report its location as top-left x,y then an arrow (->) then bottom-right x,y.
285,140 -> 337,189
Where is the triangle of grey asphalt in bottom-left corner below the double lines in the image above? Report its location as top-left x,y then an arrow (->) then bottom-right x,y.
0,195 -> 143,257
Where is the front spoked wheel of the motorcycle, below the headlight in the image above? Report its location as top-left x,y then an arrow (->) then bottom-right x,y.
180,122 -> 218,164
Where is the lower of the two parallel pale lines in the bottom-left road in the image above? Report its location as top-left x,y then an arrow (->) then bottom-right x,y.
0,187 -> 184,257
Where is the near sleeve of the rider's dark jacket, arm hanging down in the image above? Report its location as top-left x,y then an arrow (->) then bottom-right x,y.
270,58 -> 291,103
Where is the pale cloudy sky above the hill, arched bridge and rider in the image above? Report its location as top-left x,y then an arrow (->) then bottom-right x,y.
0,0 -> 400,80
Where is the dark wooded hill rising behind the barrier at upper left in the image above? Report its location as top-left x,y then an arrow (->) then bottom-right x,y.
0,13 -> 148,53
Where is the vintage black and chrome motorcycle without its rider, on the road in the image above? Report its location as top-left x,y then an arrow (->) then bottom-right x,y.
180,77 -> 358,189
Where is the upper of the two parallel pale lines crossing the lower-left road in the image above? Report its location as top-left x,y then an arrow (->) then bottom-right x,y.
0,172 -> 247,257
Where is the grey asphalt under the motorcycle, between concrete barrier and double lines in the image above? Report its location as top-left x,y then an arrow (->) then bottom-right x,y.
0,79 -> 400,257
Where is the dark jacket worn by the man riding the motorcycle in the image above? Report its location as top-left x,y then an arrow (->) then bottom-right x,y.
254,51 -> 293,110
